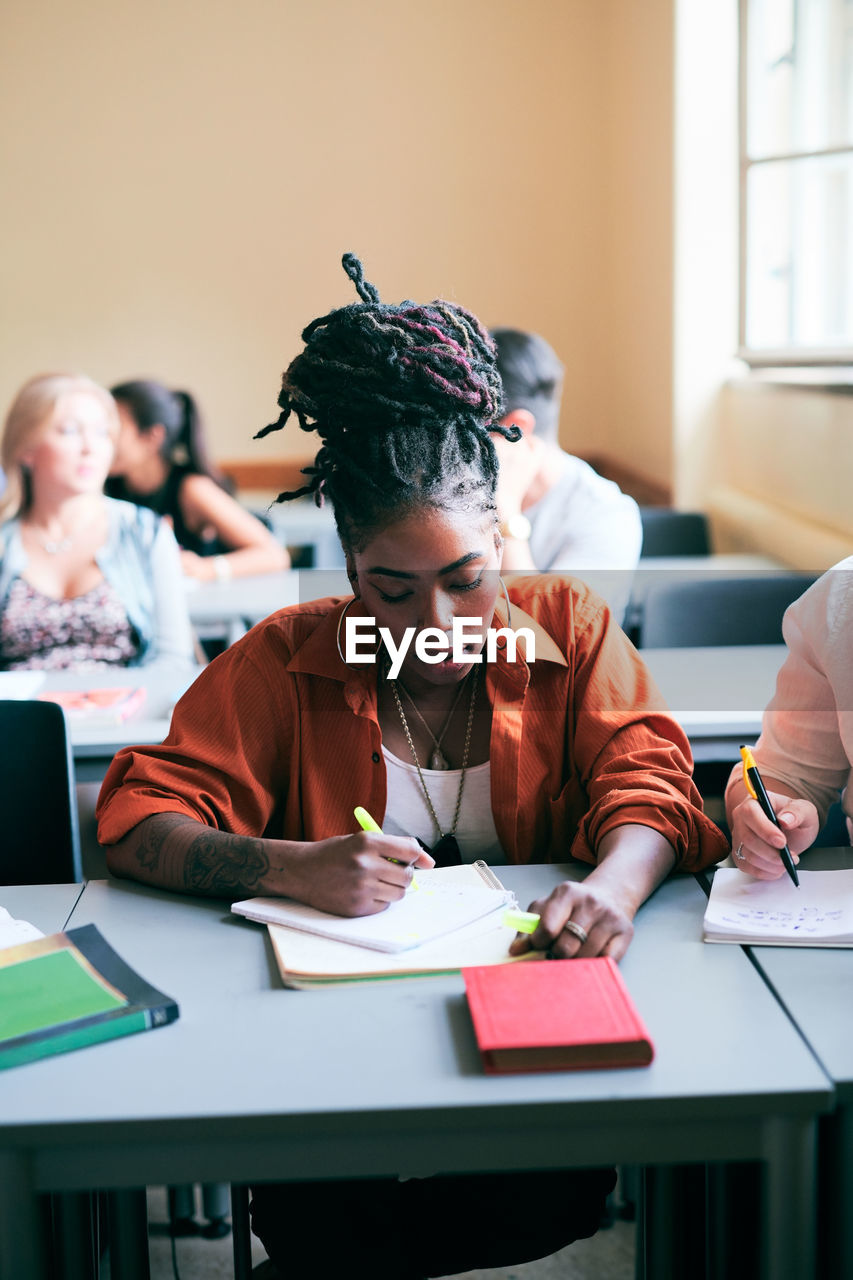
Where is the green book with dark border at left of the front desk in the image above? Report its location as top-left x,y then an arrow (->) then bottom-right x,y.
0,924 -> 178,1070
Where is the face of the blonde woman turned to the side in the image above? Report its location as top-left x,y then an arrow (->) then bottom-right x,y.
20,390 -> 115,497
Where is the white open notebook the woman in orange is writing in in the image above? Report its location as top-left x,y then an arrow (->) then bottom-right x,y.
232,861 -> 515,952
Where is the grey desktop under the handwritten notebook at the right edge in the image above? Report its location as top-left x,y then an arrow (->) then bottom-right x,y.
749,849 -> 853,1100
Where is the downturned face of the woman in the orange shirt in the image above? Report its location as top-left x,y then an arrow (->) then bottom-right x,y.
348,508 -> 501,685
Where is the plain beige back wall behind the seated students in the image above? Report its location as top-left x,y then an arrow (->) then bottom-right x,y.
0,0 -> 612,461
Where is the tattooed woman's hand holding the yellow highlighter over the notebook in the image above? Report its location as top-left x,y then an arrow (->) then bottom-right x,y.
284,831 -> 435,915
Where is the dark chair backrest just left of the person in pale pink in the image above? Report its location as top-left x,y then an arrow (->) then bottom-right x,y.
640,573 -> 815,649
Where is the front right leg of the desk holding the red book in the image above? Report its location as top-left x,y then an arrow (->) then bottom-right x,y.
761,1120 -> 814,1280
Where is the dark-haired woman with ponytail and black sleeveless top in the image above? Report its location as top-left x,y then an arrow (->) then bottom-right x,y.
106,380 -> 291,581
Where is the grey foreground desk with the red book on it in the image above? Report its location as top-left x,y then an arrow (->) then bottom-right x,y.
0,867 -> 833,1280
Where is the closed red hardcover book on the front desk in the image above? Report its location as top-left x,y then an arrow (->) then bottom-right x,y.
462,956 -> 654,1075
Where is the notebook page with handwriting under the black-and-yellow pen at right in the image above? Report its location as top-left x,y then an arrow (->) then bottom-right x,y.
703,867 -> 853,947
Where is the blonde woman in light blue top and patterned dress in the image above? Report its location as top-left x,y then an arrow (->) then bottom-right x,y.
0,374 -> 193,671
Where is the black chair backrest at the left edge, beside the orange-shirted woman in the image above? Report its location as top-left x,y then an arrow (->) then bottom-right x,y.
0,700 -> 82,884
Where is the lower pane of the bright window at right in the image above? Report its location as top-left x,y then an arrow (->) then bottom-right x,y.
745,155 -> 853,351
